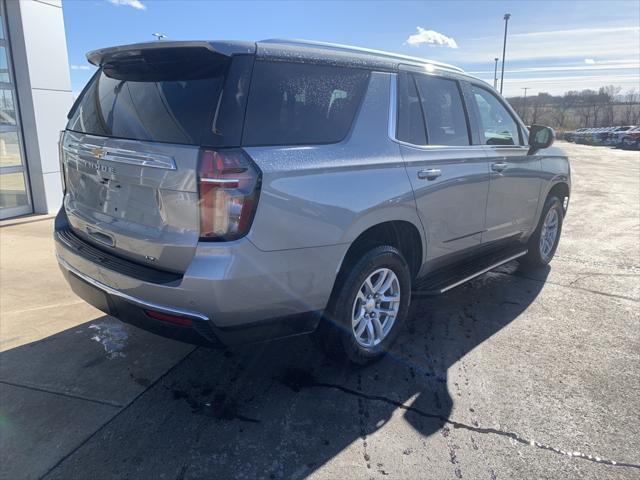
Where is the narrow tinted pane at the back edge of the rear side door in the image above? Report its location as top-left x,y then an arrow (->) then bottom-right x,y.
396,73 -> 427,145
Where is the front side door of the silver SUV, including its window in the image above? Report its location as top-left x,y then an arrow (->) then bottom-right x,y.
469,84 -> 542,243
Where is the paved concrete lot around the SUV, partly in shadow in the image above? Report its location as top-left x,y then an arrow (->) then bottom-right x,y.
0,143 -> 640,480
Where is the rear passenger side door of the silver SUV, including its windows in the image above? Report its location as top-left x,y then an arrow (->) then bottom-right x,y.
396,72 -> 489,260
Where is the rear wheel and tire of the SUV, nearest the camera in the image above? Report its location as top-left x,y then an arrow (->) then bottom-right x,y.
314,246 -> 411,365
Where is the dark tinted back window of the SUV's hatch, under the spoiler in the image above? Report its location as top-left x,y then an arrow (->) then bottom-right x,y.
67,50 -> 228,145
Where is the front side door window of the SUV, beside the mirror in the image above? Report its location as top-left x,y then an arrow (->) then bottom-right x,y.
471,85 -> 520,145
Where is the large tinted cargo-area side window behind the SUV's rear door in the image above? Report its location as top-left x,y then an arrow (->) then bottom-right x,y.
243,61 -> 369,145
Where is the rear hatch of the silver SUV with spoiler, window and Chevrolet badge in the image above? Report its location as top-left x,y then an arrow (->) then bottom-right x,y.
61,42 -> 253,273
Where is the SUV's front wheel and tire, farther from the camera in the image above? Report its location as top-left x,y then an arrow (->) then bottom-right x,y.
521,196 -> 564,268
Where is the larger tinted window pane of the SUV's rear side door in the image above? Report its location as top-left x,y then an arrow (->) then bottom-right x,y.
416,75 -> 470,146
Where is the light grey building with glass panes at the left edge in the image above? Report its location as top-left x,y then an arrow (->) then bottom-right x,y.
0,0 -> 73,219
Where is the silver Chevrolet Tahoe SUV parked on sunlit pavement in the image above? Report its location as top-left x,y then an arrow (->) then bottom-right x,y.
55,40 -> 570,363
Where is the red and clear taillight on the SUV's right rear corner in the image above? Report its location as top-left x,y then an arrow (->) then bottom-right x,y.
198,149 -> 260,241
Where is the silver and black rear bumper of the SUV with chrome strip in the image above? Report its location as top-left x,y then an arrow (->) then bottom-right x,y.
54,211 -> 346,347
